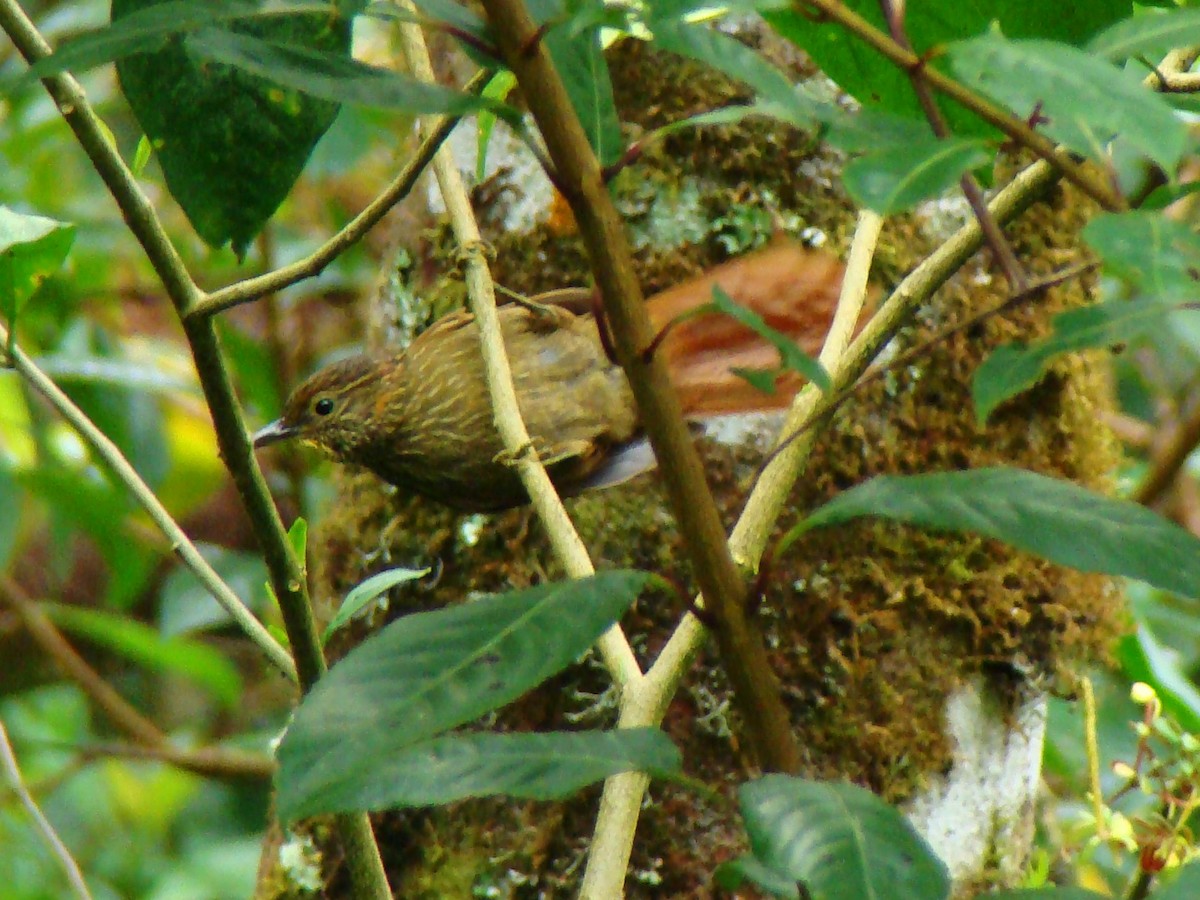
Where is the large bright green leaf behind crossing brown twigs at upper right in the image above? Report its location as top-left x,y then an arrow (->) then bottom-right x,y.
763,0 -> 1130,136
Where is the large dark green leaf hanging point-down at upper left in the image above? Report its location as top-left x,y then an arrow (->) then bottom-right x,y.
113,0 -> 350,258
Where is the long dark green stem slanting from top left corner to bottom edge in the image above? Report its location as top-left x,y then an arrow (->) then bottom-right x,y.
0,0 -> 391,900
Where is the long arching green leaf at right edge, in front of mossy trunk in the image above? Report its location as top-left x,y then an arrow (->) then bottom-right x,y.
785,468 -> 1200,596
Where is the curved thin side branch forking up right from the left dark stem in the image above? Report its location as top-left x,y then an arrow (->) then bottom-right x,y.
187,70 -> 492,317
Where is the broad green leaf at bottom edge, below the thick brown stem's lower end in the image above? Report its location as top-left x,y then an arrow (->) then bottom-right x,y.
738,775 -> 950,900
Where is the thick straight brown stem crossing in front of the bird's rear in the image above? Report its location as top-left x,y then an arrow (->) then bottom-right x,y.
482,0 -> 800,772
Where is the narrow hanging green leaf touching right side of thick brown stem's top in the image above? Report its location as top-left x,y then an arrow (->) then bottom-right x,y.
537,0 -> 624,166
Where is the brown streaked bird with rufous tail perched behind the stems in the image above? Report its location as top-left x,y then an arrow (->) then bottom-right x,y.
254,242 -> 844,512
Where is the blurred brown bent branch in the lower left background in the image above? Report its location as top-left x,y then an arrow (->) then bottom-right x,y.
0,575 -> 275,779
